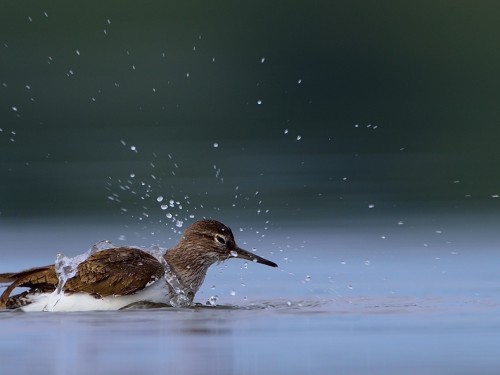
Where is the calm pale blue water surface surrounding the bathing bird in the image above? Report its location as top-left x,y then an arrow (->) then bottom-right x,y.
0,215 -> 500,374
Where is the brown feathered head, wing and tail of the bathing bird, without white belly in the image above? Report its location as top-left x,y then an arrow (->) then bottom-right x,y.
0,220 -> 277,308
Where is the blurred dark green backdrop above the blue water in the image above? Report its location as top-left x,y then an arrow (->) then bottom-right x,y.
0,1 -> 500,218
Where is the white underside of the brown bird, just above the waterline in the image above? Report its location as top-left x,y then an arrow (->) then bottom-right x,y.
21,278 -> 170,311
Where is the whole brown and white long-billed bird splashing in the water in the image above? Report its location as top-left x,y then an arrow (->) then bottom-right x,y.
0,219 -> 278,311
